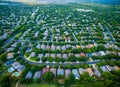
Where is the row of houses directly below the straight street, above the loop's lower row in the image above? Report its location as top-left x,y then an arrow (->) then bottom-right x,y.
24,43 -> 119,51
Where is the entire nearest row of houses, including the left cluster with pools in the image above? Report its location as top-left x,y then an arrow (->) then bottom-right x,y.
5,59 -> 120,79
